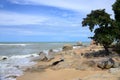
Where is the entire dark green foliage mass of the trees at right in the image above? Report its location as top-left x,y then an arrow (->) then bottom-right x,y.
82,0 -> 120,51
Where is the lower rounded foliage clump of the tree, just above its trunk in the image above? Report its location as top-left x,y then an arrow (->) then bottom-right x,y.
92,27 -> 114,46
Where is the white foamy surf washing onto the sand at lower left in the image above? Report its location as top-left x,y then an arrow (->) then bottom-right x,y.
0,54 -> 37,80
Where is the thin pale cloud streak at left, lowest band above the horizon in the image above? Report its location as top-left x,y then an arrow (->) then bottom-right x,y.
0,27 -> 56,36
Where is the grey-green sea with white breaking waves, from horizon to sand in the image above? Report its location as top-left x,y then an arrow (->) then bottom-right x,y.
0,42 -> 89,80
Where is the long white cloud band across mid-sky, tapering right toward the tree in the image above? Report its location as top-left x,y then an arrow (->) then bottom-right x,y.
0,10 -> 80,27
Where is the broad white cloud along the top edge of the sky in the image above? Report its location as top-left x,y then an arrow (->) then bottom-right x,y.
9,0 -> 115,13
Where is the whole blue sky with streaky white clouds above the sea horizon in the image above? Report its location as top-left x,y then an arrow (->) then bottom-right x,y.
0,0 -> 115,42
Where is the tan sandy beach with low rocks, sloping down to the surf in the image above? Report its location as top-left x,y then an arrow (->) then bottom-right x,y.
17,45 -> 120,80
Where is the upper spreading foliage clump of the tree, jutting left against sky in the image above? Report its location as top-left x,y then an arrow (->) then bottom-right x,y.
82,9 -> 112,31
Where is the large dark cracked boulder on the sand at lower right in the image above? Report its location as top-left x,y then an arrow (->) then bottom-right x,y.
97,58 -> 114,69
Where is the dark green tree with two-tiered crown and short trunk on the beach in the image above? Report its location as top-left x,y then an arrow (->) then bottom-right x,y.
82,9 -> 115,54
